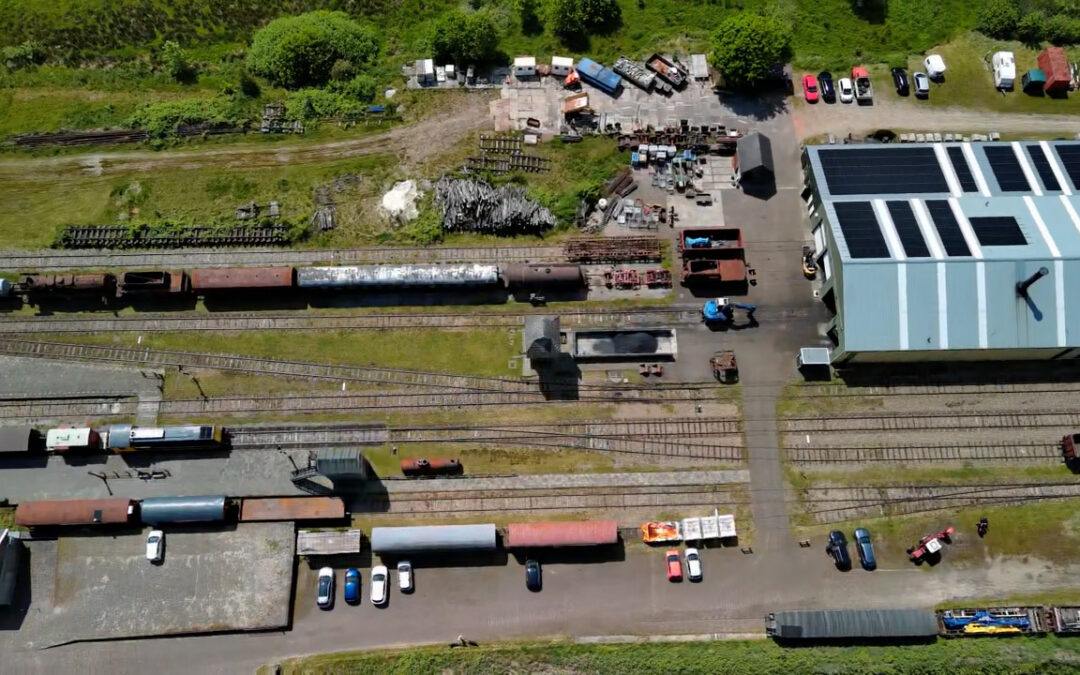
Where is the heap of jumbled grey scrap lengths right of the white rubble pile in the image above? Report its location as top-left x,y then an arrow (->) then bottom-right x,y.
435,176 -> 555,234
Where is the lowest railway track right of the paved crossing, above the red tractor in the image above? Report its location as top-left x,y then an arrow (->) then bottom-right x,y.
801,482 -> 1080,523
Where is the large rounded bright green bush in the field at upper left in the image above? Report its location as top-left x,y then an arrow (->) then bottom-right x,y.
247,10 -> 379,87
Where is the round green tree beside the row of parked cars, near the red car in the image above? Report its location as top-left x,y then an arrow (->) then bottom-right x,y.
712,13 -> 792,86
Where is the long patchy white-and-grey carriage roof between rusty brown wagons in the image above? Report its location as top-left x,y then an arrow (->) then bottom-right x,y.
296,265 -> 499,288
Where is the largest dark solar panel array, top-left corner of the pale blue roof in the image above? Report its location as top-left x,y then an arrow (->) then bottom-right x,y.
818,147 -> 948,194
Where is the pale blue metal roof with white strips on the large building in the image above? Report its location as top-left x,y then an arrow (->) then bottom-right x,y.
806,141 -> 1080,353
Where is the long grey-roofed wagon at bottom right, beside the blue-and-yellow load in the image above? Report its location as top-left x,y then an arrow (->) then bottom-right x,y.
766,609 -> 937,639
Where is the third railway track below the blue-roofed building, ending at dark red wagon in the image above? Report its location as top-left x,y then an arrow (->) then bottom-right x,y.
785,442 -> 1062,465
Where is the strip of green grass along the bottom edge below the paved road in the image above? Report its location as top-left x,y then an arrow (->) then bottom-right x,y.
267,636 -> 1080,675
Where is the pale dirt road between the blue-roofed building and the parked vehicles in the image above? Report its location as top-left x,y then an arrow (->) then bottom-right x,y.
792,97 -> 1080,138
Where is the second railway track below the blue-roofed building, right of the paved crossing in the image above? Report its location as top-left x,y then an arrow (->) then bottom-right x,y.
780,410 -> 1080,433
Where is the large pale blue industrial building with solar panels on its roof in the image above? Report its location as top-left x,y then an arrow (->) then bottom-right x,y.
802,140 -> 1080,365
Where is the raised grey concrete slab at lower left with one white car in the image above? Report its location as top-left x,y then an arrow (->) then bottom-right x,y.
9,523 -> 295,649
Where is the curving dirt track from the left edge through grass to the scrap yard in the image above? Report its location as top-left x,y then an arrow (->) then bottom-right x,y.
0,94 -> 491,180
